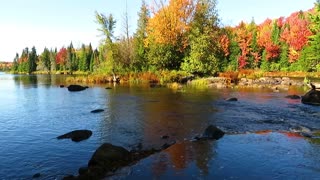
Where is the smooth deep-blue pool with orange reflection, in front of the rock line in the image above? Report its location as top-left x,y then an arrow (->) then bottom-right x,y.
126,133 -> 320,179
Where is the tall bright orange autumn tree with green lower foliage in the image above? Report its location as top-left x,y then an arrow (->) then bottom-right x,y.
146,0 -> 194,69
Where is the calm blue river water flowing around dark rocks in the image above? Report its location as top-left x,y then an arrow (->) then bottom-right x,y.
0,73 -> 320,179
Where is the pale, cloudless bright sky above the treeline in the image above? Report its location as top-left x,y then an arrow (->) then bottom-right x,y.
0,0 -> 315,61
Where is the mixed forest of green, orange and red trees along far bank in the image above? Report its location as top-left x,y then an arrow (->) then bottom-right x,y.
12,0 -> 320,77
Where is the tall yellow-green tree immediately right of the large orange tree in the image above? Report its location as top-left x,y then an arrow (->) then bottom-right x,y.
181,0 -> 220,76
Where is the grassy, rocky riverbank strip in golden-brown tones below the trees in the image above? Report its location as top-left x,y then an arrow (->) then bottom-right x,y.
8,70 -> 320,90
